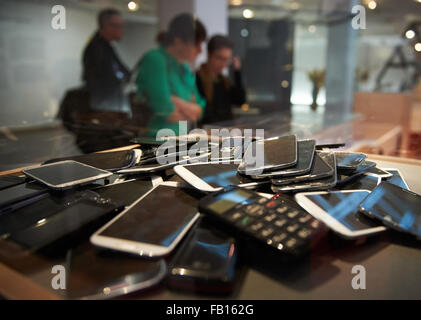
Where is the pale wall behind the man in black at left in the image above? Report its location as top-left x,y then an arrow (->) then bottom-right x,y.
0,0 -> 156,127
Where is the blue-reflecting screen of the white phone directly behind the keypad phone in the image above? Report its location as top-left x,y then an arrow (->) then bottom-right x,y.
186,163 -> 253,188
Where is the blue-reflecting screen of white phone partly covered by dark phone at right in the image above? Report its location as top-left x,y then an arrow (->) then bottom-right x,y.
307,191 -> 379,231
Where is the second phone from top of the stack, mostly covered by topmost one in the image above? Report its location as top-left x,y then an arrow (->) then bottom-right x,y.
251,140 -> 316,179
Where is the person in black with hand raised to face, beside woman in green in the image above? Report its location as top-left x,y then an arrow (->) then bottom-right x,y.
196,35 -> 246,124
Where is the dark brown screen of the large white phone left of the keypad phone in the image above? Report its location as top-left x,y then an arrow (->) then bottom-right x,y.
99,185 -> 198,247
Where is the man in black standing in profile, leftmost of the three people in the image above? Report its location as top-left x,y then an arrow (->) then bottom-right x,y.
82,9 -> 130,113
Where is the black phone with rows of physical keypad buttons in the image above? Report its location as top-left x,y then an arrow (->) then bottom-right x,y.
199,188 -> 325,257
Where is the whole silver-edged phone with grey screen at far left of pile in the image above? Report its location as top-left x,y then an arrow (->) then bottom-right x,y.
22,160 -> 112,190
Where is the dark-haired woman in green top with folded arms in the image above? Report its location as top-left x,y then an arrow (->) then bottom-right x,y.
136,14 -> 206,136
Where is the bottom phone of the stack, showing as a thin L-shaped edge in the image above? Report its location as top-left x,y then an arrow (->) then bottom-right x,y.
271,152 -> 337,192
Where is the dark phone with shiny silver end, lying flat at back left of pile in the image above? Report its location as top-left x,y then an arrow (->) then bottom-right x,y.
44,149 -> 142,171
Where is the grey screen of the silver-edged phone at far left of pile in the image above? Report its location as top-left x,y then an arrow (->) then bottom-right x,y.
24,161 -> 111,186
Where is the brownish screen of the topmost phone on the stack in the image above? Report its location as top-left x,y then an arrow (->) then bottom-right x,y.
241,135 -> 297,170
